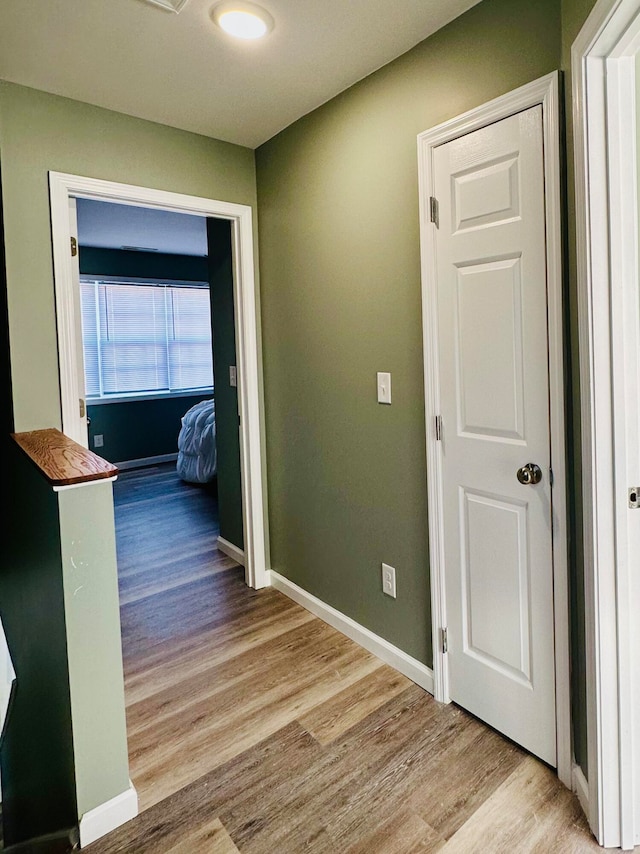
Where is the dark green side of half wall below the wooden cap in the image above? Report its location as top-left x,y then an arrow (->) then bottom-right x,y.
0,444 -> 77,846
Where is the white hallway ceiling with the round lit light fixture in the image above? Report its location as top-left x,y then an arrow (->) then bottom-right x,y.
0,0 -> 479,148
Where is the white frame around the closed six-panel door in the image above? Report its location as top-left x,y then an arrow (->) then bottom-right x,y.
418,72 -> 573,786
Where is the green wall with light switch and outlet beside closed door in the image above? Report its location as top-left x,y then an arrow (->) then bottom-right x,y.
257,0 -> 560,665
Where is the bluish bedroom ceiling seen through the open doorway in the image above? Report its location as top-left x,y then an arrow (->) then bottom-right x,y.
76,199 -> 208,255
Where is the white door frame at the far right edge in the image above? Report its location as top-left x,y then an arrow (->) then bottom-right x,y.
571,0 -> 640,849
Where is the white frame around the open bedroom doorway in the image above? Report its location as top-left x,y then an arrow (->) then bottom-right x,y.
49,172 -> 268,588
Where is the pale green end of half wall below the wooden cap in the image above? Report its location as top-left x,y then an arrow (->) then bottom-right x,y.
58,482 -> 129,818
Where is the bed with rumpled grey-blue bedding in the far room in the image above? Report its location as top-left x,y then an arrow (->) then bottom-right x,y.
176,399 -> 217,483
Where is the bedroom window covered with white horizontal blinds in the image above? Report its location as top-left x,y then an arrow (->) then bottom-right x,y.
80,278 -> 213,401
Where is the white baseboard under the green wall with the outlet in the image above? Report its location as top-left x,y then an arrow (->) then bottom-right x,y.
267,570 -> 433,694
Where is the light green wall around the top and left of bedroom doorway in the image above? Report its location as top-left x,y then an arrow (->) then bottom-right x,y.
0,81 -> 256,431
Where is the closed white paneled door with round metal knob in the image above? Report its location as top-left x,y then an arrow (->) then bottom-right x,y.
433,107 -> 556,766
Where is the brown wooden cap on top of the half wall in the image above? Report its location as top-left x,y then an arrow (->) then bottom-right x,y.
11,427 -> 118,486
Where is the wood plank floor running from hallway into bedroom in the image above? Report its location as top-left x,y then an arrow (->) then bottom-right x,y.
86,465 -> 601,854
